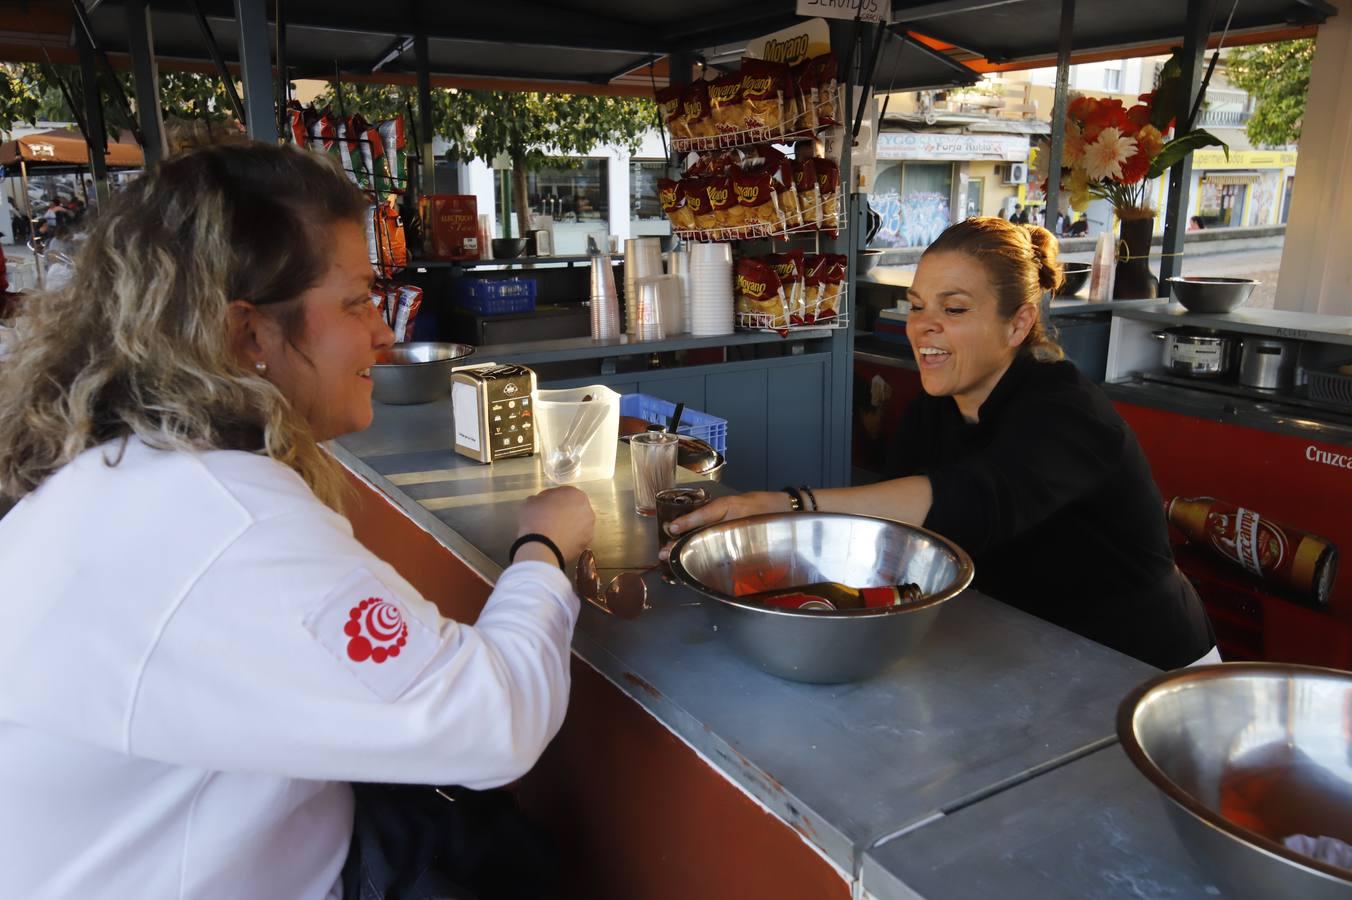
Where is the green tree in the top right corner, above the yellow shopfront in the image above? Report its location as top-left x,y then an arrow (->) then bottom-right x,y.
1225,39 -> 1314,147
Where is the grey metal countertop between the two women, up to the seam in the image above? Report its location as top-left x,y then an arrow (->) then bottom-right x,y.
335,401 -> 1200,896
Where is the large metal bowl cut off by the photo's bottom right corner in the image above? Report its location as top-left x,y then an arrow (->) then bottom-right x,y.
1117,662 -> 1352,900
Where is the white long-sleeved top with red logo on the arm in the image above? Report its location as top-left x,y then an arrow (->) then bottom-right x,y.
0,441 -> 577,900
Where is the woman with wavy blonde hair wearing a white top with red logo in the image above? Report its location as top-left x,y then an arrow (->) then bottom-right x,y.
0,145 -> 594,900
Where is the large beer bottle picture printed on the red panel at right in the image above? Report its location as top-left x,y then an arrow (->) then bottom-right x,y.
1165,497 -> 1338,607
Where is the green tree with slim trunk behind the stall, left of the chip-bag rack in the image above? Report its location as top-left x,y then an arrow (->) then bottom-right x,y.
315,84 -> 657,234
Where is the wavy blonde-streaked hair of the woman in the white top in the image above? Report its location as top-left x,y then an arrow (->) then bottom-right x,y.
0,143 -> 366,509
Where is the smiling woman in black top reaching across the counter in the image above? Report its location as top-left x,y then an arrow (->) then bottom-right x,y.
675,218 -> 1218,669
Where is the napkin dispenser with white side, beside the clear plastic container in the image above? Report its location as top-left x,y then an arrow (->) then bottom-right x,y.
450,364 -> 535,462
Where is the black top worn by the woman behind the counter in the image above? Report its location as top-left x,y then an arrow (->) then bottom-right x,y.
891,357 -> 1215,669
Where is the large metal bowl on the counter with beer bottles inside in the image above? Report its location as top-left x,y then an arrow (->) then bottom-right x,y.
671,512 -> 972,684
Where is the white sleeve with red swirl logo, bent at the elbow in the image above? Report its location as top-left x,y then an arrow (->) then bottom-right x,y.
126,511 -> 577,788
